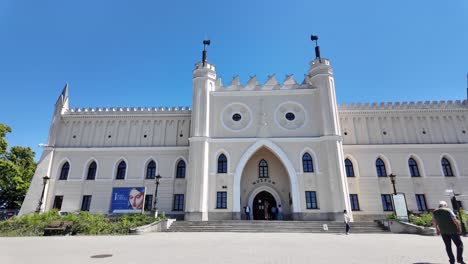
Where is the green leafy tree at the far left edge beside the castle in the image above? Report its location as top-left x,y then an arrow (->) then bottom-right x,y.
0,123 -> 37,209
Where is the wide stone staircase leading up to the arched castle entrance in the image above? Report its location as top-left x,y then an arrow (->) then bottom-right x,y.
167,220 -> 388,233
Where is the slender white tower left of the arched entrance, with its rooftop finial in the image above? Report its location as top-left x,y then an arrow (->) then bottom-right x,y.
185,40 -> 216,220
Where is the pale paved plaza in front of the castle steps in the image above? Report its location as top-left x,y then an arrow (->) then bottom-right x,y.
0,233 -> 468,264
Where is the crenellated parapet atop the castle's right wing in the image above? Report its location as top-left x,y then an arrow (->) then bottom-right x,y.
338,100 -> 468,111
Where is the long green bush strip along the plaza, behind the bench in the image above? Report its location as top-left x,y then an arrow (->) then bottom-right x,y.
0,210 -> 165,236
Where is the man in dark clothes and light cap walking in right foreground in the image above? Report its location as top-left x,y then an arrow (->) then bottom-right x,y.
432,201 -> 466,264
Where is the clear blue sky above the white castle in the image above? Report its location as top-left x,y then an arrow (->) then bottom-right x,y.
0,0 -> 468,159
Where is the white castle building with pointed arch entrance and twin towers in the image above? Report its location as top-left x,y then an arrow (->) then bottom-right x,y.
20,42 -> 468,221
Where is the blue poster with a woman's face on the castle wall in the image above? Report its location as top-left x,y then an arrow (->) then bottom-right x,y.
110,187 -> 145,214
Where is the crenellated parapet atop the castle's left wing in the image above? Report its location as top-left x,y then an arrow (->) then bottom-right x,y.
64,106 -> 192,115
